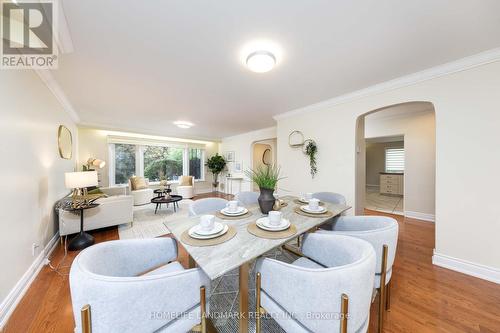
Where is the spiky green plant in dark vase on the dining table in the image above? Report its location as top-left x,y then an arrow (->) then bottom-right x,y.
245,165 -> 283,214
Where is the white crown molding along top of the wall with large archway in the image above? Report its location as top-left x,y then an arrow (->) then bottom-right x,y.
273,48 -> 500,120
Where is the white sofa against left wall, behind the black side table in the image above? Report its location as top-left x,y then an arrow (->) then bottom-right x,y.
59,189 -> 134,236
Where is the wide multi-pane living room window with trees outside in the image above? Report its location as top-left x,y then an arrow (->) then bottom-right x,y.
109,143 -> 205,185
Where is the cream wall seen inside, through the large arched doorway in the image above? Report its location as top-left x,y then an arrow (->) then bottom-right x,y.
365,107 -> 436,219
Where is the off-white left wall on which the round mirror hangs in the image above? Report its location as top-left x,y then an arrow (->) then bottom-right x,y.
0,70 -> 77,324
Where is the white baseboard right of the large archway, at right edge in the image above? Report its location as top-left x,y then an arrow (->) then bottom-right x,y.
432,250 -> 500,284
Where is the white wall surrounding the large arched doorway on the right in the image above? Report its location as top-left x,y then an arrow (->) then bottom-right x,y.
277,61 -> 500,281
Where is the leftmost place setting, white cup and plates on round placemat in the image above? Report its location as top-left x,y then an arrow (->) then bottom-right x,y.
181,215 -> 236,246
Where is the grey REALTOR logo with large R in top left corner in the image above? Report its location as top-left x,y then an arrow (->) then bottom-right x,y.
0,0 -> 57,69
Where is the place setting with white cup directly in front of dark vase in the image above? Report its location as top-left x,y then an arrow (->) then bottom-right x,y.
247,210 -> 297,239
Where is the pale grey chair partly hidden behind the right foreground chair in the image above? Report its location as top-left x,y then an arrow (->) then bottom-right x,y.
318,216 -> 399,332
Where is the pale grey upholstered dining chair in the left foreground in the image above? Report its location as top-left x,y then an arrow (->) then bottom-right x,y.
69,238 -> 210,333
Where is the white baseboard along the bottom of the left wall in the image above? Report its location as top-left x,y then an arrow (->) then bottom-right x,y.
0,232 -> 59,331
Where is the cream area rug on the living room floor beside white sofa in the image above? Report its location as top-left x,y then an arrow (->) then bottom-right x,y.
118,199 -> 193,239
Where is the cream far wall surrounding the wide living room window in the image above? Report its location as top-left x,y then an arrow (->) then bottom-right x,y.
78,127 -> 219,193
